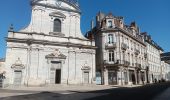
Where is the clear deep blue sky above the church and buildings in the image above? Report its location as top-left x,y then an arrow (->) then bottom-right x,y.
0,0 -> 170,58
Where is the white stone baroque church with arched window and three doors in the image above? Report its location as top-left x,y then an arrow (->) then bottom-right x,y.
5,0 -> 96,86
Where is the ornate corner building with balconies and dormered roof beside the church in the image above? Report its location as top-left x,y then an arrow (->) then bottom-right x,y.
86,12 -> 148,85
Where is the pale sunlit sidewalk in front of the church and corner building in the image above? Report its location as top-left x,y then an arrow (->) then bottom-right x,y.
0,85 -> 140,98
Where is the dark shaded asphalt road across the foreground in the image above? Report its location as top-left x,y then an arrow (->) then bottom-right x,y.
0,83 -> 170,100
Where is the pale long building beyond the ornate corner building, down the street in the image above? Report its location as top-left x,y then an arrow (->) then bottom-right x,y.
142,32 -> 166,83
